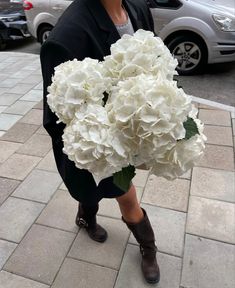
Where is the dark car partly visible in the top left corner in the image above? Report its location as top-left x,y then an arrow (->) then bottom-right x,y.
0,0 -> 31,50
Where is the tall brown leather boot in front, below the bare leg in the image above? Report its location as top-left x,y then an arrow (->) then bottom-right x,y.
122,209 -> 160,284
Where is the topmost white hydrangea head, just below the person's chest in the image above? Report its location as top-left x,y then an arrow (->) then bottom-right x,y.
104,29 -> 178,82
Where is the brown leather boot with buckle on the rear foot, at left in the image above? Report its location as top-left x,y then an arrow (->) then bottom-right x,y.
75,203 -> 108,242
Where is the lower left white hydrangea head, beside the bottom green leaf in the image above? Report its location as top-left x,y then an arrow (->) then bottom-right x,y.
63,104 -> 128,182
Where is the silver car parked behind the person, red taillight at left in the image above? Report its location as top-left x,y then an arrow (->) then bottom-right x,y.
23,0 -> 235,75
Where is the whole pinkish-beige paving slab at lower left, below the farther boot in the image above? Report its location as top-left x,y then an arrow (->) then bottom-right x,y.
3,224 -> 76,285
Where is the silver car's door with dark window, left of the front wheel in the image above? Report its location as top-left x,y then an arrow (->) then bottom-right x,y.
148,0 -> 183,35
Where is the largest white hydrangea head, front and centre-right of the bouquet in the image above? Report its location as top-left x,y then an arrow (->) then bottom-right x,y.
106,75 -> 191,160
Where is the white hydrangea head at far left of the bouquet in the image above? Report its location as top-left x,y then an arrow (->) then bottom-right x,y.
47,58 -> 111,124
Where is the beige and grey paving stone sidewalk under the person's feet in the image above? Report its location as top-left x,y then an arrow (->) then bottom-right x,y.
0,52 -> 235,288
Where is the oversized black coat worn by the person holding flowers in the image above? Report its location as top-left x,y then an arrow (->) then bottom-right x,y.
40,0 -> 153,205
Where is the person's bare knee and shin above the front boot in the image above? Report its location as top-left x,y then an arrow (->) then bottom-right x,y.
116,185 -> 144,223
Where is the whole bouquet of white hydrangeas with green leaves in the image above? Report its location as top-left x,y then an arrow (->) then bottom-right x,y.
47,30 -> 206,191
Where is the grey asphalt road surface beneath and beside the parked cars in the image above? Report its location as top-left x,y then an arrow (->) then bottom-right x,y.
0,39 -> 235,107
